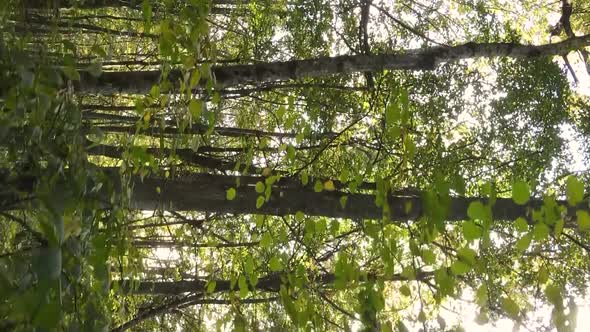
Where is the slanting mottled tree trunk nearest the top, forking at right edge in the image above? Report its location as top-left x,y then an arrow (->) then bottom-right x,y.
76,35 -> 590,94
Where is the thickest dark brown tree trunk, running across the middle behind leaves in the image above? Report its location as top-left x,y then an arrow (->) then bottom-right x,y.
125,174 -> 583,227
